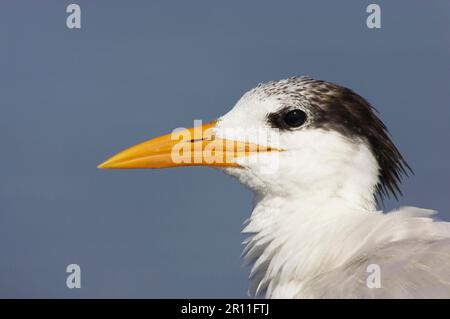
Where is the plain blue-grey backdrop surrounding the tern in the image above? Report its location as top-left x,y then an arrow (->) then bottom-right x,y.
0,0 -> 450,298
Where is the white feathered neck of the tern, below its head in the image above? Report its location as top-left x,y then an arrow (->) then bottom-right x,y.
243,190 -> 375,298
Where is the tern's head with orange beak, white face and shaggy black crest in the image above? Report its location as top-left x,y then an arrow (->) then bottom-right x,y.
99,77 -> 410,208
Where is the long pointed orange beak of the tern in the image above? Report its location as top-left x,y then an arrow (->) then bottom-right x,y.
98,122 -> 278,169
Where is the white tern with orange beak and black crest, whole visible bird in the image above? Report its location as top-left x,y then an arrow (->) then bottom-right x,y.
98,76 -> 450,299
